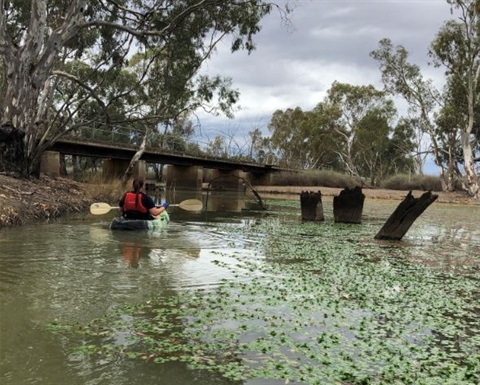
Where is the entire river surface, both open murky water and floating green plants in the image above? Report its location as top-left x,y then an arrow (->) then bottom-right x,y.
0,200 -> 480,385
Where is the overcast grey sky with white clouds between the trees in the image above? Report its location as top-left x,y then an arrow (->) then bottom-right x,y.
192,0 -> 452,160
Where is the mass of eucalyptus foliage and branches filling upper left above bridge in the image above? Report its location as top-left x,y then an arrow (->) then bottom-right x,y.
0,0 -> 289,175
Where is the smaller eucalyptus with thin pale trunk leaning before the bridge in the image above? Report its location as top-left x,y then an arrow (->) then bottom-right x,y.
122,44 -> 239,183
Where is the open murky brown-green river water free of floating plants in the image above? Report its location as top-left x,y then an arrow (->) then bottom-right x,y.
0,198 -> 480,385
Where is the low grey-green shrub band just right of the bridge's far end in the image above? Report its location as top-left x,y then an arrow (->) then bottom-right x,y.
271,170 -> 361,188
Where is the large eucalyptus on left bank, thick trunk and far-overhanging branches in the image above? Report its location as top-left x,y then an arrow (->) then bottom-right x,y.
0,0 -> 279,176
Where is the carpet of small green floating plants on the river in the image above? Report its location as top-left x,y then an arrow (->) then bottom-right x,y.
52,202 -> 480,385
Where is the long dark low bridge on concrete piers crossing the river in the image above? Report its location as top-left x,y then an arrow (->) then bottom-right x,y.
44,137 -> 282,188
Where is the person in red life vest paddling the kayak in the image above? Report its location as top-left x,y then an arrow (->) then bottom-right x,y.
120,178 -> 168,220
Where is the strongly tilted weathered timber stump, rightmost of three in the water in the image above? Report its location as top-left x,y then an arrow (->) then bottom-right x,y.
375,191 -> 438,240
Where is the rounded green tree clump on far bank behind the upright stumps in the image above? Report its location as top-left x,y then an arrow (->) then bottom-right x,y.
269,82 -> 414,185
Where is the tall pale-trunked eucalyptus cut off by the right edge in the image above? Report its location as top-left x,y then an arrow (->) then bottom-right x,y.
430,0 -> 480,198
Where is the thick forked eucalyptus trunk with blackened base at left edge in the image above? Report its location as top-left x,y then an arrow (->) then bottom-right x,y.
0,0 -> 87,177
